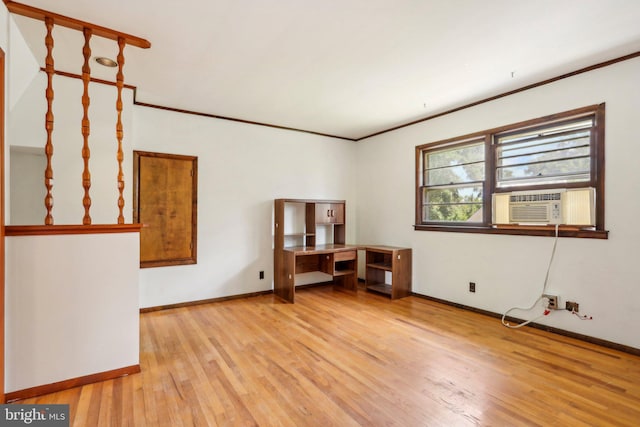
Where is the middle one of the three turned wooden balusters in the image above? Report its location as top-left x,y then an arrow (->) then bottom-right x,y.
82,27 -> 91,225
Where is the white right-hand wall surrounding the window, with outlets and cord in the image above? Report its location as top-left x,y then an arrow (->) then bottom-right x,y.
356,58 -> 640,348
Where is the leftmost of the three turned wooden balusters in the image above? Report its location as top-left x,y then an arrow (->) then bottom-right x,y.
44,17 -> 54,225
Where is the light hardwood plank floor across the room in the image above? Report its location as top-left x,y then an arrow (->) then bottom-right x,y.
15,287 -> 640,427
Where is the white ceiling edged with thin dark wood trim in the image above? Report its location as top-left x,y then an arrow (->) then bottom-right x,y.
14,0 -> 640,139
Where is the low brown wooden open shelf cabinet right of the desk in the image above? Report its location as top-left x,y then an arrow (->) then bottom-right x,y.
364,246 -> 411,299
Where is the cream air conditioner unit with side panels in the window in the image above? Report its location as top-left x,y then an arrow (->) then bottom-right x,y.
492,188 -> 595,226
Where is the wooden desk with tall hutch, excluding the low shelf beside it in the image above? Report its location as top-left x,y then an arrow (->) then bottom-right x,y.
273,199 -> 358,302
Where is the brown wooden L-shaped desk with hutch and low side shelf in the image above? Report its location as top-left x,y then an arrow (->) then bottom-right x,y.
273,199 -> 411,302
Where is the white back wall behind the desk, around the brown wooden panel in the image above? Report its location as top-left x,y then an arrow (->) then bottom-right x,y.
133,107 -> 357,307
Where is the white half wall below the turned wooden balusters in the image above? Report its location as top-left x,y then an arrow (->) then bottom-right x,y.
5,232 -> 140,392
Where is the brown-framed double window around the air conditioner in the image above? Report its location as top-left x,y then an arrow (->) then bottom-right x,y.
415,104 -> 606,238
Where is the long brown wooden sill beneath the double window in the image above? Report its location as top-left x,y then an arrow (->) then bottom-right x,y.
413,224 -> 609,239
